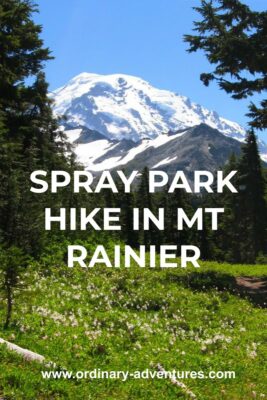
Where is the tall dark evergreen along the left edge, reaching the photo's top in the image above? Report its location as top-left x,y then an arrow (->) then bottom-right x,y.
0,0 -> 72,327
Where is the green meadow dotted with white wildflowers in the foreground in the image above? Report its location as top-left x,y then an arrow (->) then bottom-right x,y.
0,241 -> 267,400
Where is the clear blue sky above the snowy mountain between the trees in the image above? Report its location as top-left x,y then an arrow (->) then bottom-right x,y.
35,0 -> 267,141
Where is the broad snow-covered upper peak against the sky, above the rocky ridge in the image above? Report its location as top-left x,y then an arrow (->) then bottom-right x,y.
52,72 -> 248,142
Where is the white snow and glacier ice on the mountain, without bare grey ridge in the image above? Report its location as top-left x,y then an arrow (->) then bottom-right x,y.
51,73 -> 267,171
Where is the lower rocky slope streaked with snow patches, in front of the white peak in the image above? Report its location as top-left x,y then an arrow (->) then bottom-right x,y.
65,124 -> 241,175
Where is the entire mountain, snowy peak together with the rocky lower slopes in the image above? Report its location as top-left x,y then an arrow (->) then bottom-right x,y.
51,73 -> 267,175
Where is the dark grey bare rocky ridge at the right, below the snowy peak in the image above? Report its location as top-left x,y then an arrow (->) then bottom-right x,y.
123,124 -> 241,176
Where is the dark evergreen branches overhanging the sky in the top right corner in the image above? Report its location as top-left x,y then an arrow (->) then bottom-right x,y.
184,0 -> 267,129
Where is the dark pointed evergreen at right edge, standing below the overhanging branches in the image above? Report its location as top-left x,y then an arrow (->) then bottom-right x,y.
209,136 -> 267,263
